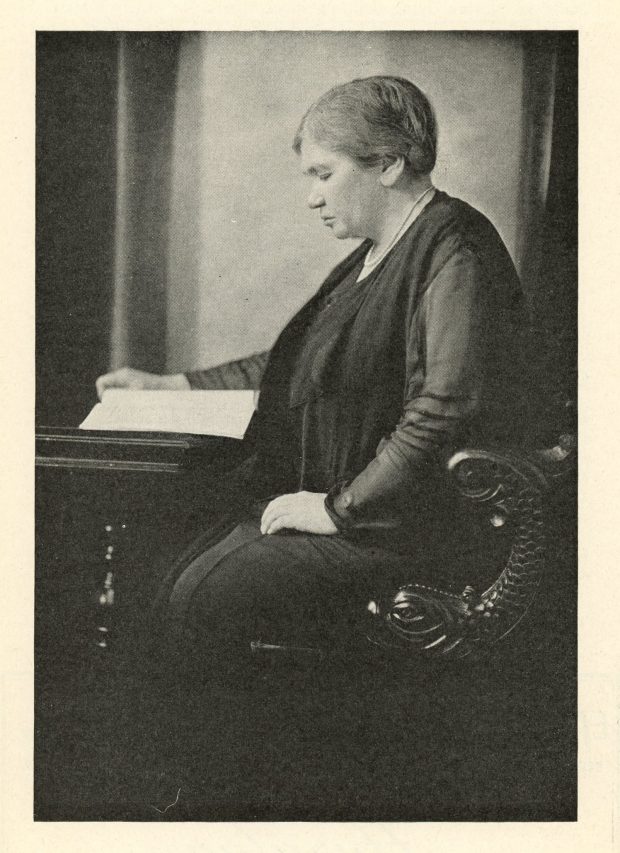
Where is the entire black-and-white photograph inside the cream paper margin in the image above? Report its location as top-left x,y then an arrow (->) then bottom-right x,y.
32,29 -> 580,824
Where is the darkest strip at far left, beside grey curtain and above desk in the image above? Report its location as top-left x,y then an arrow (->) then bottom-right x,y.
36,33 -> 118,426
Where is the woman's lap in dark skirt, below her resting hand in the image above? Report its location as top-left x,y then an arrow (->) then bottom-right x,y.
163,500 -> 402,666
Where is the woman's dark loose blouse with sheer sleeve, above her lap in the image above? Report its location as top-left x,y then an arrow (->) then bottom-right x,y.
188,192 -> 526,540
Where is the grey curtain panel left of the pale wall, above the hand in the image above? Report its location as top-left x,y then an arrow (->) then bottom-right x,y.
110,33 -> 182,372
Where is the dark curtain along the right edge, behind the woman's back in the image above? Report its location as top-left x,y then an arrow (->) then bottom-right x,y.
523,32 -> 578,416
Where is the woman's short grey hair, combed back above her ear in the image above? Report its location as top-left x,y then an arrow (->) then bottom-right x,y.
293,75 -> 437,175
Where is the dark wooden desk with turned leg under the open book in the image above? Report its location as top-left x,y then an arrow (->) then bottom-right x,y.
35,428 -> 247,681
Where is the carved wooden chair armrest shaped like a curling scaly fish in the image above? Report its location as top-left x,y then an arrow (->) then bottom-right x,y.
368,434 -> 576,658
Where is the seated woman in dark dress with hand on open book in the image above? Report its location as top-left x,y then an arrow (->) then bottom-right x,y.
98,76 -> 523,684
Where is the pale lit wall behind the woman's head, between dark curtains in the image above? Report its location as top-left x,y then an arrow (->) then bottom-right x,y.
167,32 -> 524,371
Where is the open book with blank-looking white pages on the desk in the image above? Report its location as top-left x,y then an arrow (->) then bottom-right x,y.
80,388 -> 255,438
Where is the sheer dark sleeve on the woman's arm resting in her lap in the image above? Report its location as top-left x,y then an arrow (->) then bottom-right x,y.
326,249 -> 489,529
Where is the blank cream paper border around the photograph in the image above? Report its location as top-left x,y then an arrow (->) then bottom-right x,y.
0,0 -> 620,853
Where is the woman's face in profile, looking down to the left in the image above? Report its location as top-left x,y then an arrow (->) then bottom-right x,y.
300,138 -> 385,240
